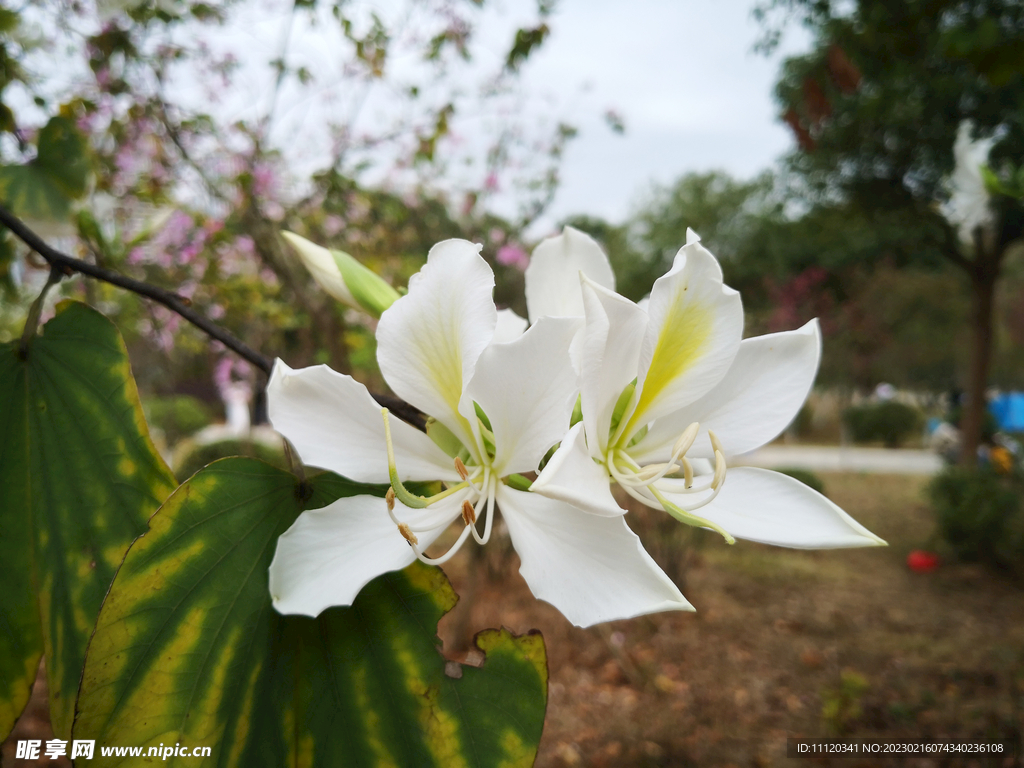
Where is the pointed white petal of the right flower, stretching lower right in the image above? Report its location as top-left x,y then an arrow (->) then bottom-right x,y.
666,467 -> 885,549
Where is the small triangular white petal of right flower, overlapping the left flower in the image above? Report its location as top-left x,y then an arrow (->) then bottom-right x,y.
529,422 -> 626,516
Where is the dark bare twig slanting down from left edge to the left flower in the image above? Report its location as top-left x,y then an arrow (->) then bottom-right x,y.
0,201 -> 273,376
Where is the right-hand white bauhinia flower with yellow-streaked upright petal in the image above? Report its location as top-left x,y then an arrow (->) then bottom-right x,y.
530,231 -> 885,548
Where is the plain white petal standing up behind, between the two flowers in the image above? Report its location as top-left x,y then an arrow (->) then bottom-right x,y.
525,226 -> 615,323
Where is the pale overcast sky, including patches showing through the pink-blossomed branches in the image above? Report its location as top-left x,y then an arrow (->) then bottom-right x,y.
182,0 -> 808,237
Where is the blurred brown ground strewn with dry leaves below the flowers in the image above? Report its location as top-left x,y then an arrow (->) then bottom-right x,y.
2,474 -> 1024,768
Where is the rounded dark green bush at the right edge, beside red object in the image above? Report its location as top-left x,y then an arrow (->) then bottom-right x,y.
927,466 -> 1024,573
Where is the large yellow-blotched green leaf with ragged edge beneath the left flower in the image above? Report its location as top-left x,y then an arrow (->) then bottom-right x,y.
75,458 -> 547,768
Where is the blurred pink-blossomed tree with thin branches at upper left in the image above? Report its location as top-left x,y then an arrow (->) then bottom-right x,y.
0,0 -> 573,409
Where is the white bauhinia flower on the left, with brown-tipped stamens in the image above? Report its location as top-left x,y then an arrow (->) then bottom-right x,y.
267,241 -> 692,626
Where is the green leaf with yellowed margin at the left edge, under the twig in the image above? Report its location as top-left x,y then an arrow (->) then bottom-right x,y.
0,302 -> 175,738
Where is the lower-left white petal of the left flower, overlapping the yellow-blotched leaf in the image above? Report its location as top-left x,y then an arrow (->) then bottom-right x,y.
270,496 -> 462,616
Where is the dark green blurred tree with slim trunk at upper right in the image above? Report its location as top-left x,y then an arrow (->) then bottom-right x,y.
756,0 -> 1024,463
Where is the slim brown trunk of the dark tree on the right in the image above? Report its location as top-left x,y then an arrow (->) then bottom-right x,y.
959,249 -> 999,467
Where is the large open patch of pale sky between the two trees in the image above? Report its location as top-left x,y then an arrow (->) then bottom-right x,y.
516,0 -> 808,233
